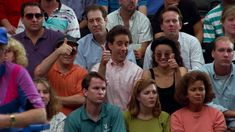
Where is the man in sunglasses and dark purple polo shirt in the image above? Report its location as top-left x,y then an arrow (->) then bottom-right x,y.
14,2 -> 63,77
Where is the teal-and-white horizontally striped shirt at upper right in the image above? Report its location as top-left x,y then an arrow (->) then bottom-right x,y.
203,4 -> 224,43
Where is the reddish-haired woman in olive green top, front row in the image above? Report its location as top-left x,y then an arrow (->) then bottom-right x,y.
124,79 -> 170,132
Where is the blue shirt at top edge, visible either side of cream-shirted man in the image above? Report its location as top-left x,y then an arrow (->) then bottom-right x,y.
98,0 -> 146,13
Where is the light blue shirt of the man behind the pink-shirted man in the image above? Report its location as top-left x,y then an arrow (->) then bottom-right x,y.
74,34 -> 136,71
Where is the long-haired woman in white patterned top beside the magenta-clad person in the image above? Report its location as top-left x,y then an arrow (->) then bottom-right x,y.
33,78 -> 66,132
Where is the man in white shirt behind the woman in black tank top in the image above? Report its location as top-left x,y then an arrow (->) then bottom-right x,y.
144,6 -> 204,70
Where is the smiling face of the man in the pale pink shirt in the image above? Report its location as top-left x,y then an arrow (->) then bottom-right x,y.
109,34 -> 130,63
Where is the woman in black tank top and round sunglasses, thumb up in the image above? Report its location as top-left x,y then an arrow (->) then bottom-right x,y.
142,37 -> 187,114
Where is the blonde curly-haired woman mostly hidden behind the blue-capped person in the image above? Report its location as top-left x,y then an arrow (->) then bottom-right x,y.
5,38 -> 28,67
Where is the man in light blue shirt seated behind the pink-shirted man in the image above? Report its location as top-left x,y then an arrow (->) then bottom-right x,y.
75,5 -> 135,71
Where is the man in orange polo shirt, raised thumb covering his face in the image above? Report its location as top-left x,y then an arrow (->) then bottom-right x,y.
35,35 -> 87,115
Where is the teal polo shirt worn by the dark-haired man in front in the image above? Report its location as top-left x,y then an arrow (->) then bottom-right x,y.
64,103 -> 126,132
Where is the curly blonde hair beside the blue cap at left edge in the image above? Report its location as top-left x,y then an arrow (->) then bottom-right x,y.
7,38 -> 28,67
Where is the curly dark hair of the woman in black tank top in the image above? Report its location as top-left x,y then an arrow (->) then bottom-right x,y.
151,36 -> 184,67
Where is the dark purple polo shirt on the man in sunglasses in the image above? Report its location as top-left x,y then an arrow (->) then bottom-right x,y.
13,29 -> 63,77
